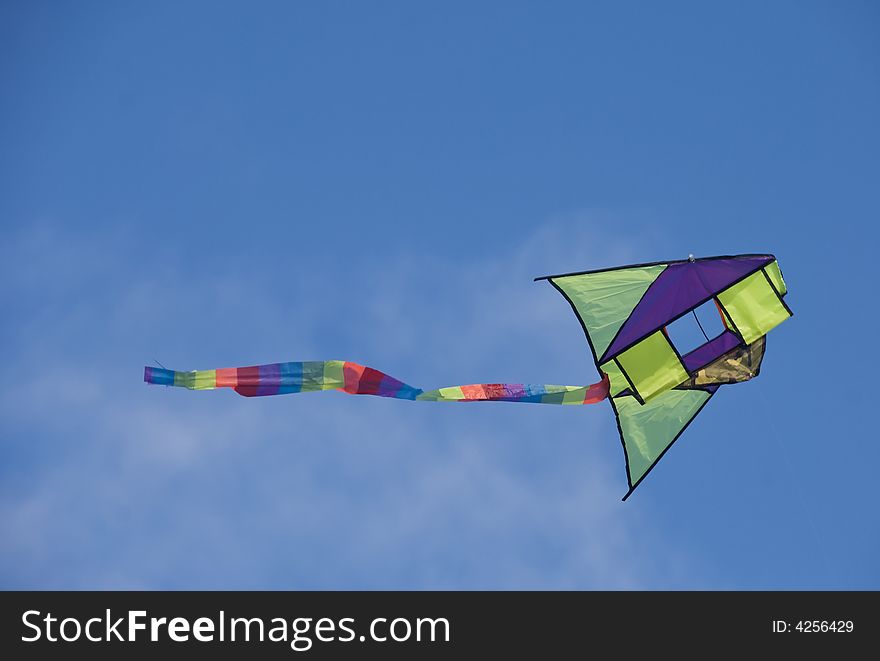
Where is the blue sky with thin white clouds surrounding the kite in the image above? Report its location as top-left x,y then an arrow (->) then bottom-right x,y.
0,2 -> 880,589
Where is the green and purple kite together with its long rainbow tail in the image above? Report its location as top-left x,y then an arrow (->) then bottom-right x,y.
144,254 -> 792,500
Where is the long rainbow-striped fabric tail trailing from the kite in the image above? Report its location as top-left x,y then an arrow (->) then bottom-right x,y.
144,360 -> 610,404
